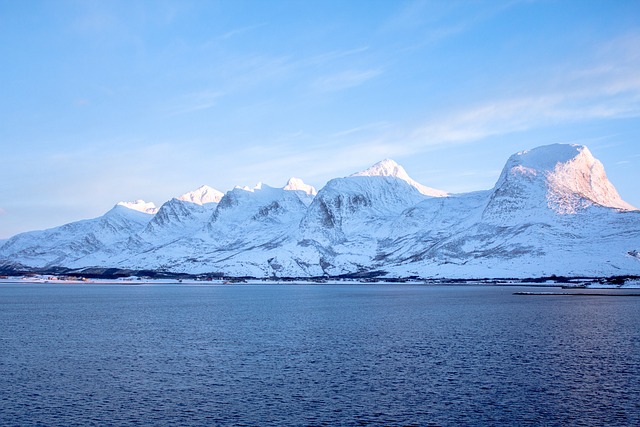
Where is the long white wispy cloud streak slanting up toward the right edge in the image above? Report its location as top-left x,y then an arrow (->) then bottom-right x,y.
410,37 -> 640,152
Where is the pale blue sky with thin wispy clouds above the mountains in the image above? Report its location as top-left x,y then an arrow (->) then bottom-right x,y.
0,0 -> 640,239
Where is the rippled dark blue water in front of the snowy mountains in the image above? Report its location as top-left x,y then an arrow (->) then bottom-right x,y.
0,284 -> 640,426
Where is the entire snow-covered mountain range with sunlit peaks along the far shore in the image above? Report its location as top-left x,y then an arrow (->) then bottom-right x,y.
0,144 -> 640,278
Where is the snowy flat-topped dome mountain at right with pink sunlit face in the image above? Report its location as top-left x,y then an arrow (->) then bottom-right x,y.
378,145 -> 640,277
